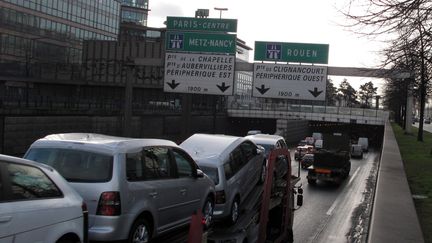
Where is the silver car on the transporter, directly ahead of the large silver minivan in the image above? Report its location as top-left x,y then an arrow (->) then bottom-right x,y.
180,134 -> 266,224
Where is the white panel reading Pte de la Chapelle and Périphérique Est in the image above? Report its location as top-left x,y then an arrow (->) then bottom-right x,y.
164,52 -> 235,95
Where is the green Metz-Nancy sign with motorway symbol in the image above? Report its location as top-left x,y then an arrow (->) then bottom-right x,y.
166,31 -> 236,54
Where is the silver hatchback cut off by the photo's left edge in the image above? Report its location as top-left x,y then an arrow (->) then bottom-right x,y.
0,155 -> 88,243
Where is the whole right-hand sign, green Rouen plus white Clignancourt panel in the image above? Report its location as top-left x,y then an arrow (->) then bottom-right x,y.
252,41 -> 329,101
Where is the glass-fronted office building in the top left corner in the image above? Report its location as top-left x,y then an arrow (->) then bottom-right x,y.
0,0 -> 120,73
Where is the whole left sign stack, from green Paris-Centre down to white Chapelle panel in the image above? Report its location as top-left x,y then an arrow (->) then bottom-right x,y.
164,17 -> 237,95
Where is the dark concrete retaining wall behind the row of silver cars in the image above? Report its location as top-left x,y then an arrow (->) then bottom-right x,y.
0,115 -> 227,156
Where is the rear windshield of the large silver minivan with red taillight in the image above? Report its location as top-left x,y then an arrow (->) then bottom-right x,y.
25,148 -> 113,183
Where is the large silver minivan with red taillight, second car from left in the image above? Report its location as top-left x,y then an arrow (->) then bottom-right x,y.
25,133 -> 215,242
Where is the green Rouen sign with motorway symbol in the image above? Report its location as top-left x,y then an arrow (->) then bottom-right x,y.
254,41 -> 329,64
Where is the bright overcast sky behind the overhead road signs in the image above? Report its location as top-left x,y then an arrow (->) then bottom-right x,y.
148,0 -> 382,92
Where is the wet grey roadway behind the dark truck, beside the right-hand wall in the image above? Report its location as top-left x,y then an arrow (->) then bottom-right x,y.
293,150 -> 379,242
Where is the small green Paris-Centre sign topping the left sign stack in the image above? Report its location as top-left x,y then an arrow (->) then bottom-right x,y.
167,17 -> 237,32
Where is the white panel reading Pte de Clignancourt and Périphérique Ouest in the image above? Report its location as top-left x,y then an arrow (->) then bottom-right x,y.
252,63 -> 327,101
